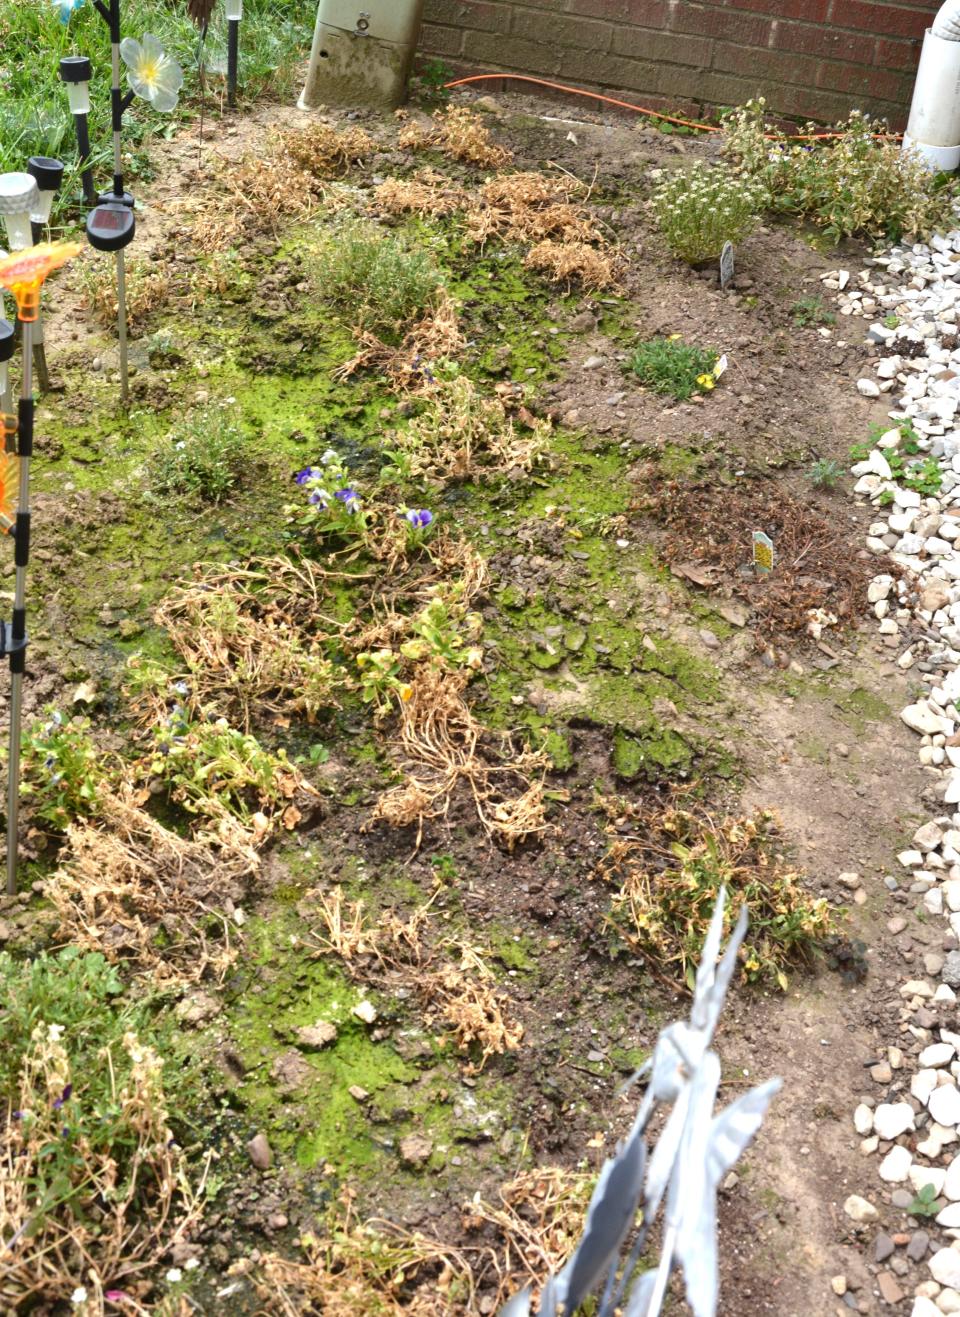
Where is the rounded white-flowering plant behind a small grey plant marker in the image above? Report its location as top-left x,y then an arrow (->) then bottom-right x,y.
653,161 -> 766,265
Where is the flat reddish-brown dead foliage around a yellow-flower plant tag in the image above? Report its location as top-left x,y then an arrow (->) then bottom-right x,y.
635,469 -> 877,652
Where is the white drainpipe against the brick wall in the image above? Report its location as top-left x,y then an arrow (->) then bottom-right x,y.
903,0 -> 960,170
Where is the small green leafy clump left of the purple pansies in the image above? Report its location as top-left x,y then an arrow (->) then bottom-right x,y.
149,403 -> 249,503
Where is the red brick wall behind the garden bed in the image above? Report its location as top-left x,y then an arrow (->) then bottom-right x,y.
420,0 -> 940,128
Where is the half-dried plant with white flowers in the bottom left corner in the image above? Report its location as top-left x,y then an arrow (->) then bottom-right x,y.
0,1023 -> 201,1317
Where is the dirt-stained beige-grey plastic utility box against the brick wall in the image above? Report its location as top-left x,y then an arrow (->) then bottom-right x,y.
299,0 -> 423,109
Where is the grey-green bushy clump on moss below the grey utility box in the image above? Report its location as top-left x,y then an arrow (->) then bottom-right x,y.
312,220 -> 444,344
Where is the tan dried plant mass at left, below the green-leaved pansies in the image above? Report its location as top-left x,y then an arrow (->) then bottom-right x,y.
46,785 -> 252,981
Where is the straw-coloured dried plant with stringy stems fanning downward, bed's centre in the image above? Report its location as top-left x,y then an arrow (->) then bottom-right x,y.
374,664 -> 547,851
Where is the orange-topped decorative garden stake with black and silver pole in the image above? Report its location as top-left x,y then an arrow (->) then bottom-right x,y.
0,242 -> 80,894
